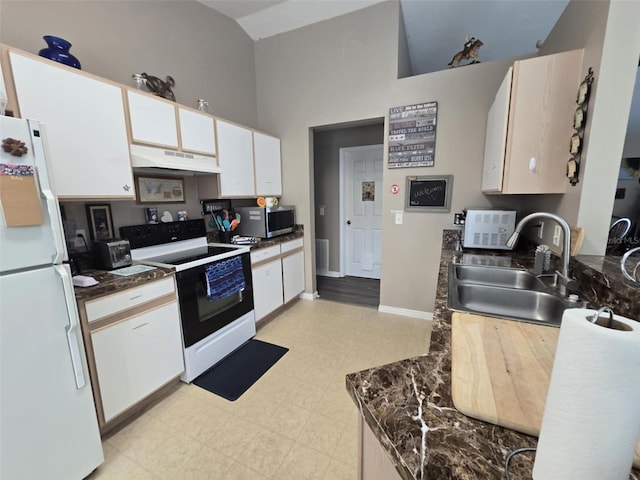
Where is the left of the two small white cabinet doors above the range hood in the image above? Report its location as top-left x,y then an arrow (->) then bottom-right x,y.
127,90 -> 178,149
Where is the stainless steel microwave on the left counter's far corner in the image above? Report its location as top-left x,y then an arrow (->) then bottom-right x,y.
234,205 -> 296,238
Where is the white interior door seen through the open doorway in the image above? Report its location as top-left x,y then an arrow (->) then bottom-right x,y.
340,145 -> 383,278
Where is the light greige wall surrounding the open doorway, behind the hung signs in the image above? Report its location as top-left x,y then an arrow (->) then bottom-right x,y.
256,1 -> 524,312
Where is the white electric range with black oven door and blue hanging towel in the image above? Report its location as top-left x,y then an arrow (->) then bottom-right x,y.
120,219 -> 256,383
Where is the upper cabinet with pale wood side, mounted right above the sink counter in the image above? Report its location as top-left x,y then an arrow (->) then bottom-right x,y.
482,50 -> 582,194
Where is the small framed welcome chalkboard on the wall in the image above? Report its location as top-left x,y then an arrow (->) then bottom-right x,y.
404,175 -> 453,213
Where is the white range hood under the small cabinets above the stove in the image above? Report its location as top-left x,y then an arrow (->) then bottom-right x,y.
129,145 -> 221,176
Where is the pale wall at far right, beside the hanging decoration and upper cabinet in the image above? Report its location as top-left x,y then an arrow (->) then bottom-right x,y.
539,0 -> 640,255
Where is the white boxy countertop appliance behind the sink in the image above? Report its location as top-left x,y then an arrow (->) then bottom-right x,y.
462,209 -> 516,250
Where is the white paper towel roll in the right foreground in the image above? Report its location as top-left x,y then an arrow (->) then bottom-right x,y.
533,309 -> 640,480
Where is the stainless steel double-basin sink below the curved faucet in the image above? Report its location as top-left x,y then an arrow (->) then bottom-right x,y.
447,262 -> 584,327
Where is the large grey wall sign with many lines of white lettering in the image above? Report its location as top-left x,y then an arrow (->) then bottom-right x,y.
388,102 -> 438,168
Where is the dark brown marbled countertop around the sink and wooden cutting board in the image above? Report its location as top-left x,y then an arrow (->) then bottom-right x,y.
346,231 -> 640,480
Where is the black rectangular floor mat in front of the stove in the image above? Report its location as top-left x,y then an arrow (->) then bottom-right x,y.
193,340 -> 289,401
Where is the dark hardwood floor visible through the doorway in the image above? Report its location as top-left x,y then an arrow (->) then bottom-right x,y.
316,276 -> 380,308
